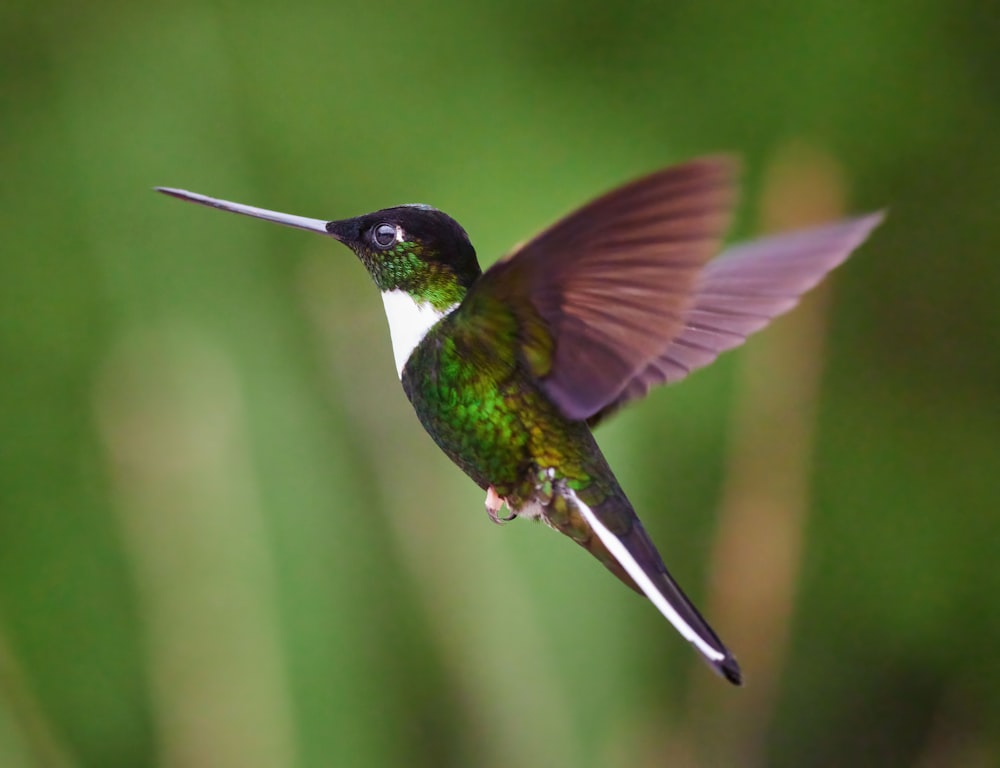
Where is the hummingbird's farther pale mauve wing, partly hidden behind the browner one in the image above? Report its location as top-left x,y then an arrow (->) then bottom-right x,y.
590,213 -> 883,425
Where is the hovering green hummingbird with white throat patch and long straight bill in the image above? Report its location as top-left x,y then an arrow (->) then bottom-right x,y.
156,157 -> 882,685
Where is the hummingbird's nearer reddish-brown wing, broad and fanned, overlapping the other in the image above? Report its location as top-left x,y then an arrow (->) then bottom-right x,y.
468,158 -> 736,420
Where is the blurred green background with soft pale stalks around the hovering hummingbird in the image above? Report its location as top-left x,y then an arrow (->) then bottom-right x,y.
0,0 -> 1000,768
